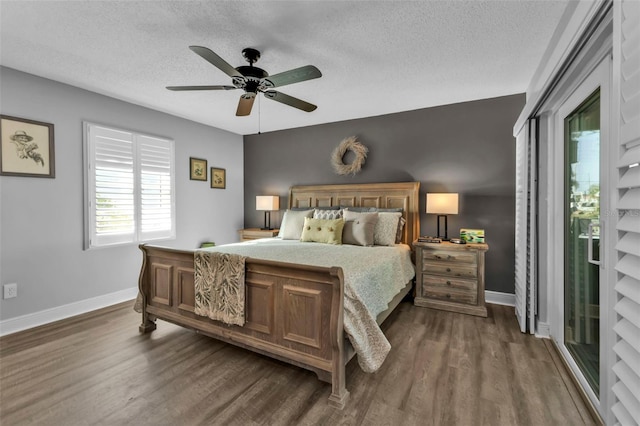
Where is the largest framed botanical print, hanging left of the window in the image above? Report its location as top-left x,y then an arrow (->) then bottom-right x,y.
0,115 -> 55,178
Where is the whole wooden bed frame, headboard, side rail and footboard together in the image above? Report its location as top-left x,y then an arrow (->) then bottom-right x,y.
138,182 -> 420,408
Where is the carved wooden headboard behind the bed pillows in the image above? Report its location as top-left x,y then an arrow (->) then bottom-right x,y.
289,182 -> 420,245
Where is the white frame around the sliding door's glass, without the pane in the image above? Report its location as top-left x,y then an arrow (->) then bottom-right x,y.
548,55 -> 615,418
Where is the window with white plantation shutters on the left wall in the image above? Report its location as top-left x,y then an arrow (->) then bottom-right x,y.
84,123 -> 175,248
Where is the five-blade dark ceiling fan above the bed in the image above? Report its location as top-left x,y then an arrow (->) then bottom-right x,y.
167,46 -> 322,116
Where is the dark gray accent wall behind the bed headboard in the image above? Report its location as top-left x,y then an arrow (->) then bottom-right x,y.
244,94 -> 525,293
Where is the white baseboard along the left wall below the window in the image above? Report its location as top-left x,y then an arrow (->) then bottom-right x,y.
0,287 -> 138,336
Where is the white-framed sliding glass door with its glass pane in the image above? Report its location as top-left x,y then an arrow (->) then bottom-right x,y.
548,58 -> 612,411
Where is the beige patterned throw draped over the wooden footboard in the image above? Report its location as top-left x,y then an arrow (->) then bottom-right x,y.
193,250 -> 246,326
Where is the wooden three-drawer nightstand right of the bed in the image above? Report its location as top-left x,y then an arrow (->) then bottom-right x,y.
413,241 -> 489,317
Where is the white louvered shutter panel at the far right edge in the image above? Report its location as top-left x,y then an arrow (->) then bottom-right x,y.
612,0 -> 640,425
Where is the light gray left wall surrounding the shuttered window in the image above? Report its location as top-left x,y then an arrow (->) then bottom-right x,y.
0,68 -> 244,326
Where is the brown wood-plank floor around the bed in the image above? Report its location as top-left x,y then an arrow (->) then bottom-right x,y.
0,302 -> 593,426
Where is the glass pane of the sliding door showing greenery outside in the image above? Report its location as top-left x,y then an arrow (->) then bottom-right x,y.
563,88 -> 600,395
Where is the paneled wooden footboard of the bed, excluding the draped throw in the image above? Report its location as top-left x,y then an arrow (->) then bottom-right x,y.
138,244 -> 349,408
